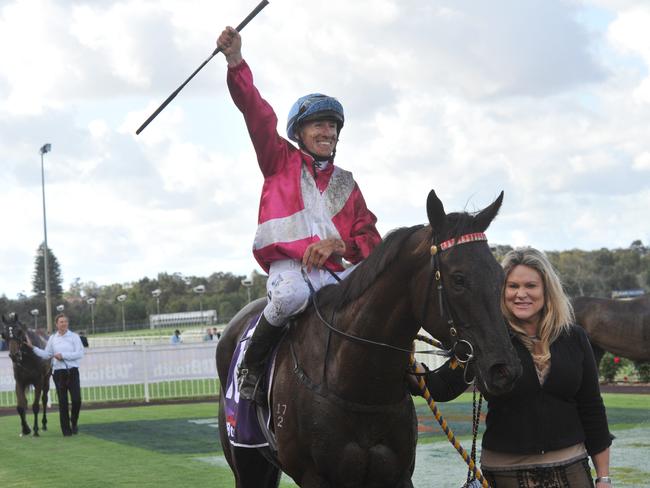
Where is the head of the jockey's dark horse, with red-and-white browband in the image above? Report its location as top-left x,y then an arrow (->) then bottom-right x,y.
424,190 -> 521,395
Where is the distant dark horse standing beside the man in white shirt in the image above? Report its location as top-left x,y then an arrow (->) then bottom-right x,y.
2,314 -> 52,436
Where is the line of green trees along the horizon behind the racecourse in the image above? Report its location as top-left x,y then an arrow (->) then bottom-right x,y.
0,240 -> 650,333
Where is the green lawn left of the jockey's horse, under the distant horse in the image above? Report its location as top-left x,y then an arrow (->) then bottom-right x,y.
0,402 -> 291,488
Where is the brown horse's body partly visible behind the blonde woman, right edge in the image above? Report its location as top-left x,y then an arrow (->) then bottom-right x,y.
572,295 -> 650,363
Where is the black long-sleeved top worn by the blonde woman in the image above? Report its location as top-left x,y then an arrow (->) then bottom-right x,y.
426,325 -> 612,455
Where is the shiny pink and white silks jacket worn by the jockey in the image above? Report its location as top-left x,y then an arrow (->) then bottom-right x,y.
227,61 -> 381,325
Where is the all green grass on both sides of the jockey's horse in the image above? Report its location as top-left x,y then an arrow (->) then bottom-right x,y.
0,394 -> 650,488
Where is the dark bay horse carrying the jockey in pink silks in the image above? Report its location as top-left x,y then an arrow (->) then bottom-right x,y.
217,191 -> 521,488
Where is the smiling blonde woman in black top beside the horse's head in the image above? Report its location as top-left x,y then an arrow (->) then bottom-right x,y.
412,248 -> 612,488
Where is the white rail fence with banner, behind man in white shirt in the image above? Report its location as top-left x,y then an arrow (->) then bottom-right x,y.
0,342 -> 218,406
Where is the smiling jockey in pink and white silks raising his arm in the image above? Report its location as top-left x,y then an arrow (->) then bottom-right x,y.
217,27 -> 381,402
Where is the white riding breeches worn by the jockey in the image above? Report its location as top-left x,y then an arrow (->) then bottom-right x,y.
264,259 -> 354,327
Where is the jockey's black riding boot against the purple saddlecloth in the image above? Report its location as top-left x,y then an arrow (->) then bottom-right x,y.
237,315 -> 284,405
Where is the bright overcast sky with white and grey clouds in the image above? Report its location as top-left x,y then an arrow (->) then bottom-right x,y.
0,0 -> 650,298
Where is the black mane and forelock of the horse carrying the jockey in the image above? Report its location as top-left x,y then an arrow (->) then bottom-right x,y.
317,212 -> 484,306
